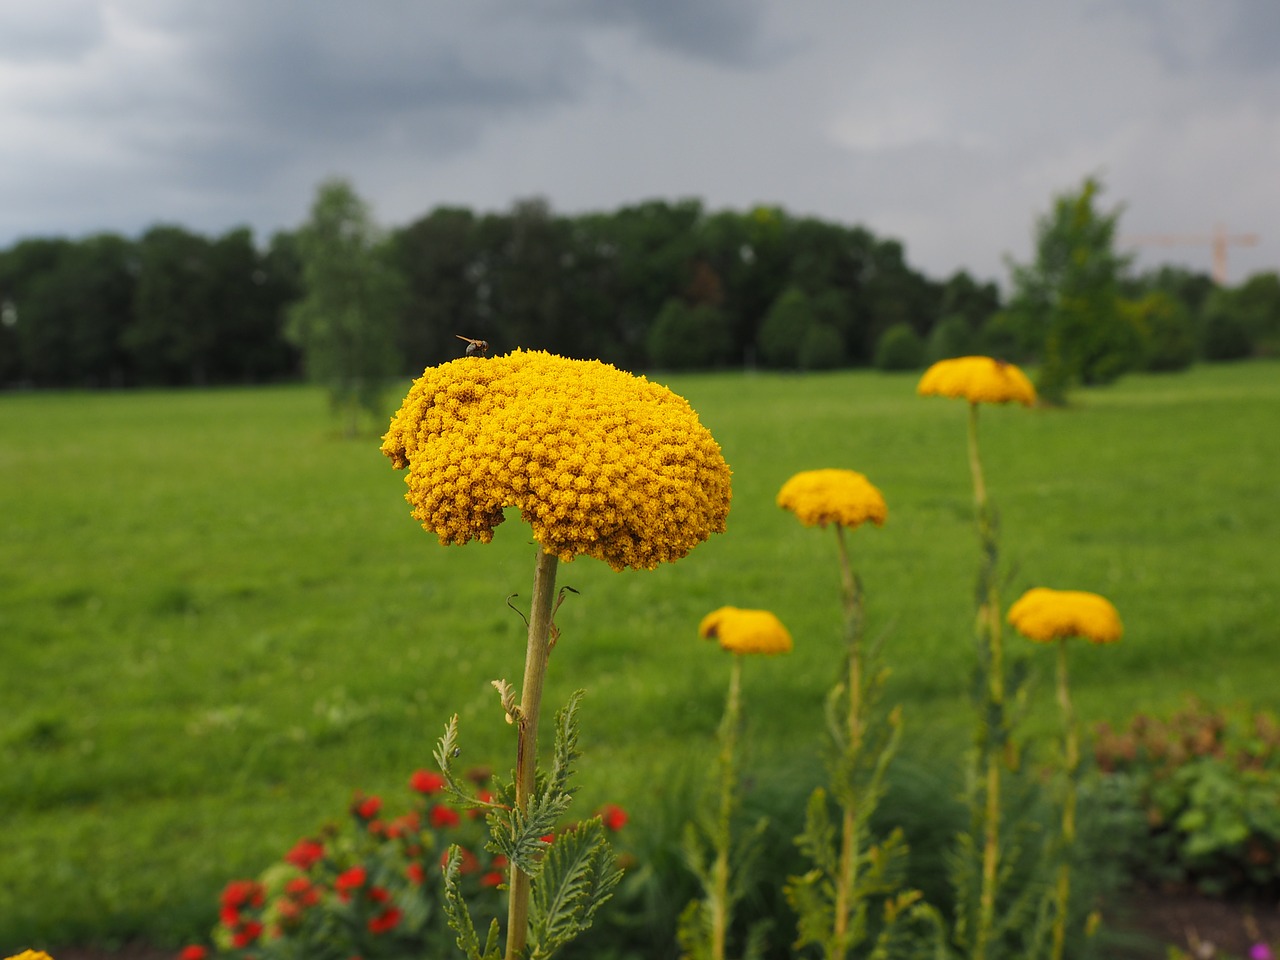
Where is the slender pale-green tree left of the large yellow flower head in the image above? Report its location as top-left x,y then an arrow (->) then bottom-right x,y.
285,179 -> 406,435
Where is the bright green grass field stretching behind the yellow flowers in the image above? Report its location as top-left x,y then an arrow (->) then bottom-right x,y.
0,362 -> 1280,952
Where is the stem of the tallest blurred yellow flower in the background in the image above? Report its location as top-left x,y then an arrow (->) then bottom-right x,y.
969,402 -> 1005,960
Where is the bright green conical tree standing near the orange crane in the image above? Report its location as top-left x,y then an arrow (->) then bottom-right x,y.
1010,177 -> 1142,403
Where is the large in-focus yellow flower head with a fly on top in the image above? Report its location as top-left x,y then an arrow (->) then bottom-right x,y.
383,349 -> 731,570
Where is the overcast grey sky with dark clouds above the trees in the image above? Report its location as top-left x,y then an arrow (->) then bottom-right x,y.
0,0 -> 1280,283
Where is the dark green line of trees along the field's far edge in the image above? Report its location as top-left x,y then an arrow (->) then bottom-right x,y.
0,180 -> 1280,404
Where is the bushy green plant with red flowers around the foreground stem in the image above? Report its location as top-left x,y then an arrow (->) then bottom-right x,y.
182,757 -> 627,960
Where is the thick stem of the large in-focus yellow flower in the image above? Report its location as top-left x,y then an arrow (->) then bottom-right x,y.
507,549 -> 559,960
